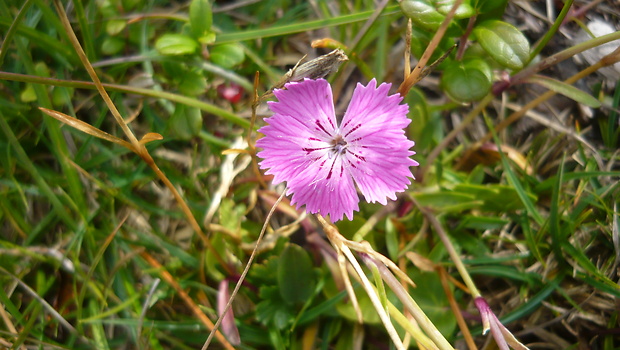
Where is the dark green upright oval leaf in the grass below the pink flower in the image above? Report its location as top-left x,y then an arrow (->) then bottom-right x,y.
278,244 -> 314,304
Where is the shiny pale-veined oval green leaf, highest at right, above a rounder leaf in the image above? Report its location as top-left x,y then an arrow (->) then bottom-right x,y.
473,20 -> 530,69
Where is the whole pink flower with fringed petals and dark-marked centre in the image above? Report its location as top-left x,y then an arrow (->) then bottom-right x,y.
256,79 -> 418,221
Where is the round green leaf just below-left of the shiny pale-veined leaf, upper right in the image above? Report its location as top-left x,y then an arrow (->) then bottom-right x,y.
441,58 -> 493,102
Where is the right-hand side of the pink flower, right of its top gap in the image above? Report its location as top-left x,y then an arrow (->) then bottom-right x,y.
341,79 -> 418,205
